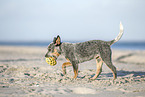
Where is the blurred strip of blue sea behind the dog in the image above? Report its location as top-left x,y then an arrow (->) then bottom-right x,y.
0,41 -> 145,50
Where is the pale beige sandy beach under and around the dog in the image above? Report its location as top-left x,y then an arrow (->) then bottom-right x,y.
0,46 -> 145,97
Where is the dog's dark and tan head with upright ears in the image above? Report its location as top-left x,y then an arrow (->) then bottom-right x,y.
45,35 -> 61,60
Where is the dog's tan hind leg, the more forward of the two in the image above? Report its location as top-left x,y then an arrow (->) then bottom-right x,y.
90,57 -> 103,80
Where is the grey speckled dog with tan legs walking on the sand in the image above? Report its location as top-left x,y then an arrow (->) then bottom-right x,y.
45,22 -> 124,80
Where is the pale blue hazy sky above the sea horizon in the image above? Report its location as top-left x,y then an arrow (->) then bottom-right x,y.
0,0 -> 145,42
